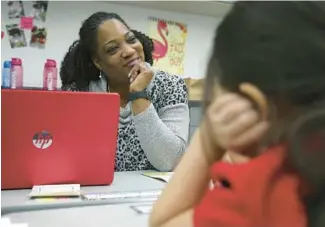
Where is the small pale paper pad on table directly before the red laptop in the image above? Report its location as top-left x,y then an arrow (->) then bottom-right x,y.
29,184 -> 81,198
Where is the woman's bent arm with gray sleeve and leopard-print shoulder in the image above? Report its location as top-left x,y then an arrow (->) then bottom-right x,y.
132,75 -> 190,171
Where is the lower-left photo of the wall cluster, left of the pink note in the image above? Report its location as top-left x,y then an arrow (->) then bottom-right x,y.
6,24 -> 27,48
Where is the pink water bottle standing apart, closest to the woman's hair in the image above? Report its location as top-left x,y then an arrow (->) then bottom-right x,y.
43,59 -> 58,91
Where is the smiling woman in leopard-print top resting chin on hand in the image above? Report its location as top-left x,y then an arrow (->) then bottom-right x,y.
60,12 -> 189,171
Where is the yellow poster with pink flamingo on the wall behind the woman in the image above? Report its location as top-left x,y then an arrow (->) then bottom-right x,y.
148,17 -> 187,76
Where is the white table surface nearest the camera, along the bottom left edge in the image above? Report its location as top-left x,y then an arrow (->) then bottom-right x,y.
4,204 -> 149,227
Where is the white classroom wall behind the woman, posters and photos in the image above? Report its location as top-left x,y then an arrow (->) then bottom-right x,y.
1,1 -> 220,87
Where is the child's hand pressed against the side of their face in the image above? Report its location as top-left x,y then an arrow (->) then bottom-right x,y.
207,93 -> 269,159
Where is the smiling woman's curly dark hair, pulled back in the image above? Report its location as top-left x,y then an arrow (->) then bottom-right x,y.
60,12 -> 154,90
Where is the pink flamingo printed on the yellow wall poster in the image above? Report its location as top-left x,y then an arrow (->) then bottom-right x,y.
152,20 -> 168,62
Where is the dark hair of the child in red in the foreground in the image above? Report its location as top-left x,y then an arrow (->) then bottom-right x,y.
205,1 -> 325,227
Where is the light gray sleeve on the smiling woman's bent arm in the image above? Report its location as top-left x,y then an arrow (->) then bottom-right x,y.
133,103 -> 189,171
